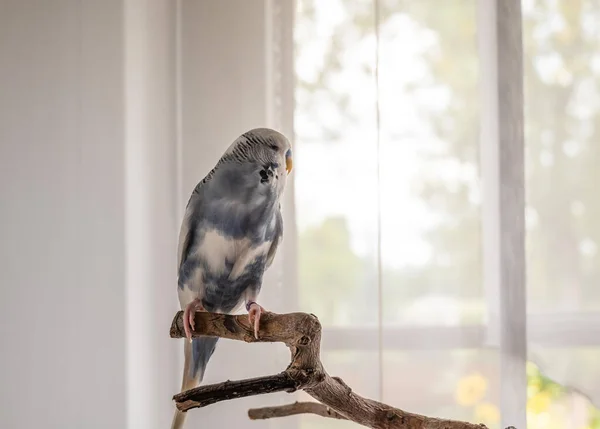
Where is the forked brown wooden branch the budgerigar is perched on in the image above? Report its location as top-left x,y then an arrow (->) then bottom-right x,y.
170,311 -> 486,429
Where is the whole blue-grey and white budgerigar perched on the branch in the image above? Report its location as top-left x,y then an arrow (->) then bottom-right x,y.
171,128 -> 292,429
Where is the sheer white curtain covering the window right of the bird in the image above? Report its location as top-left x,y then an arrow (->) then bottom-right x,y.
294,0 -> 600,429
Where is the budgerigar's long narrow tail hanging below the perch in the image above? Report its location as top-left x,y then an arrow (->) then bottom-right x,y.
171,337 -> 218,429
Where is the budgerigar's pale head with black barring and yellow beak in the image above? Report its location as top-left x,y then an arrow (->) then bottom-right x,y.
225,128 -> 293,177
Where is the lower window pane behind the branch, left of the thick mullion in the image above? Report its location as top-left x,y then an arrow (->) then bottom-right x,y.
300,349 -> 502,429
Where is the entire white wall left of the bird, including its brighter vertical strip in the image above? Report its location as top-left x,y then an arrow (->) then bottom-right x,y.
0,0 -> 179,429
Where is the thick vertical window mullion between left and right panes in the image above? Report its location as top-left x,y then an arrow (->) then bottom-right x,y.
478,0 -> 527,428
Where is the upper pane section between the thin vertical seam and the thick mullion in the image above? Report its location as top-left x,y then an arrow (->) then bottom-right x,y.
380,0 -> 485,325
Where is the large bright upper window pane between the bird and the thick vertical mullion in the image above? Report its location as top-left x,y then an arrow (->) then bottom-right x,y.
295,0 -> 484,325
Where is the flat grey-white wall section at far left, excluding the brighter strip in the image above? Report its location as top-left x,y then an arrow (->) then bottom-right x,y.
0,0 -> 126,429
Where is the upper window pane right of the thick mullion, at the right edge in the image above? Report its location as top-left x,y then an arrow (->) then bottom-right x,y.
523,0 -> 600,312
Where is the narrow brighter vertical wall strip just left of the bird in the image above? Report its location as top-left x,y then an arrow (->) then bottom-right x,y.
124,0 -> 180,429
